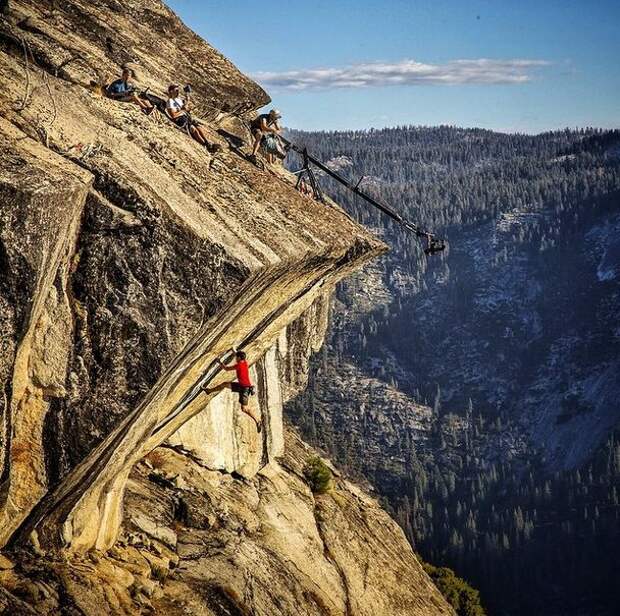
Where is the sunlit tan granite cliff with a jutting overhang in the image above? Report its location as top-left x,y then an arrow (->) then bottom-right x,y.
0,0 -> 451,614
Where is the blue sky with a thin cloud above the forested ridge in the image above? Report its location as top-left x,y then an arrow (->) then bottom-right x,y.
167,0 -> 620,132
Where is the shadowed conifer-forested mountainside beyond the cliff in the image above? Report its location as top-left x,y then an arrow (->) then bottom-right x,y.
288,127 -> 620,616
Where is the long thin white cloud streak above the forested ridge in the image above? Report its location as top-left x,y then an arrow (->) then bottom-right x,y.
252,58 -> 550,90
